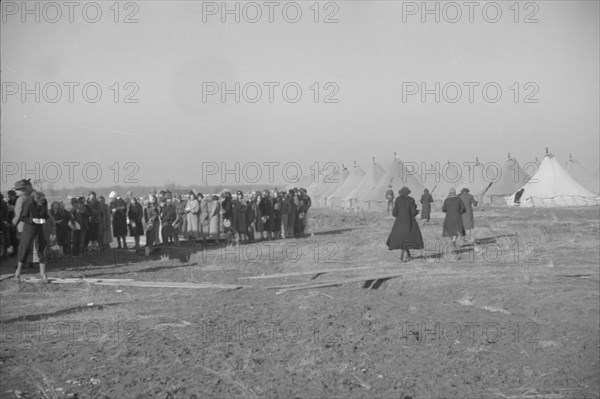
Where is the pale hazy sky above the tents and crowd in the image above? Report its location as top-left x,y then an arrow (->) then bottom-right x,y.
1,1 -> 600,191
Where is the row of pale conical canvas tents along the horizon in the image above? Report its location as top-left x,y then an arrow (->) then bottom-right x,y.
288,153 -> 600,211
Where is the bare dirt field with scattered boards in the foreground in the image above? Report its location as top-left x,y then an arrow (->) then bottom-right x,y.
0,207 -> 600,399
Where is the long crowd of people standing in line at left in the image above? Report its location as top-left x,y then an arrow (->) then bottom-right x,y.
0,180 -> 311,279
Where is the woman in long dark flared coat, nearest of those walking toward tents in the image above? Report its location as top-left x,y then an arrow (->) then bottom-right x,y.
386,187 -> 424,262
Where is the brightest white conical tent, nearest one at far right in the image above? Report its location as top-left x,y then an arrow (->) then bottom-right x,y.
506,154 -> 600,208
